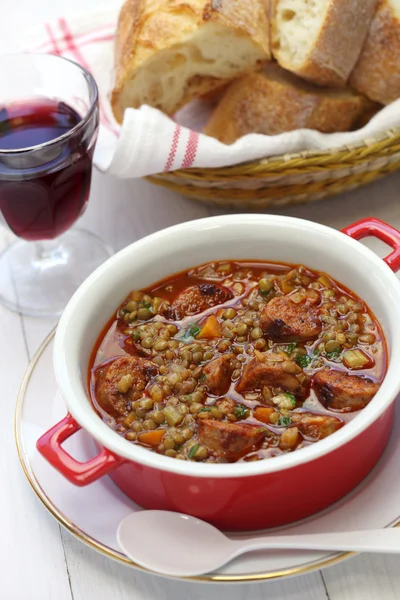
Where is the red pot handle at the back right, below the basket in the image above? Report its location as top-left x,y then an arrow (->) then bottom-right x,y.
342,217 -> 400,272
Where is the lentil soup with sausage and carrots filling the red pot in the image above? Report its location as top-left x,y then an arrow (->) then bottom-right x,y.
89,261 -> 387,463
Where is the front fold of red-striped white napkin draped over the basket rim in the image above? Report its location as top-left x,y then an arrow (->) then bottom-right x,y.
96,100 -> 400,178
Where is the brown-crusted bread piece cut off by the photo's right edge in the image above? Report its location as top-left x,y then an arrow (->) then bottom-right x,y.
350,0 -> 400,104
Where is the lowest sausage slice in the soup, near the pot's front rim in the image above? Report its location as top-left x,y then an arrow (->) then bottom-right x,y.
199,419 -> 265,462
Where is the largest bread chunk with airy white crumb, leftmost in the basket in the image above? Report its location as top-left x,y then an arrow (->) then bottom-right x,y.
111,0 -> 270,121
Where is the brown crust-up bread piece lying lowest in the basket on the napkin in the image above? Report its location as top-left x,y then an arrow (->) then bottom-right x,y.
204,63 -> 373,144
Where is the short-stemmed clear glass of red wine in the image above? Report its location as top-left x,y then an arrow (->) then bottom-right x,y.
0,54 -> 111,316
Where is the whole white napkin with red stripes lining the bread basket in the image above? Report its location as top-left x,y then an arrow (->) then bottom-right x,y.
21,9 -> 400,178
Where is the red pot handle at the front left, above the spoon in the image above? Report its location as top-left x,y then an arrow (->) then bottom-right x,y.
36,413 -> 125,486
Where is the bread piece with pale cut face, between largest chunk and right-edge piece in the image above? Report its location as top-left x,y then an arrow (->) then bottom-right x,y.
272,0 -> 378,87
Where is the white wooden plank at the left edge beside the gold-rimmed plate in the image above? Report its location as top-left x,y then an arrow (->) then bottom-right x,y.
0,307 -> 71,600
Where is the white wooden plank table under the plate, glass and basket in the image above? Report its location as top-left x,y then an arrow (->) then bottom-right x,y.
0,0 -> 400,600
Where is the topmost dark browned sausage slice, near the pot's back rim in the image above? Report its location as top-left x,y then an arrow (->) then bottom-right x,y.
164,283 -> 233,321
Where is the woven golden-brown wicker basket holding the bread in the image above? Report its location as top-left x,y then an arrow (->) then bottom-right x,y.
148,128 -> 400,210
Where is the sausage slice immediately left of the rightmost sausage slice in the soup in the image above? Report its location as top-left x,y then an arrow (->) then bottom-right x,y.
236,358 -> 309,396
